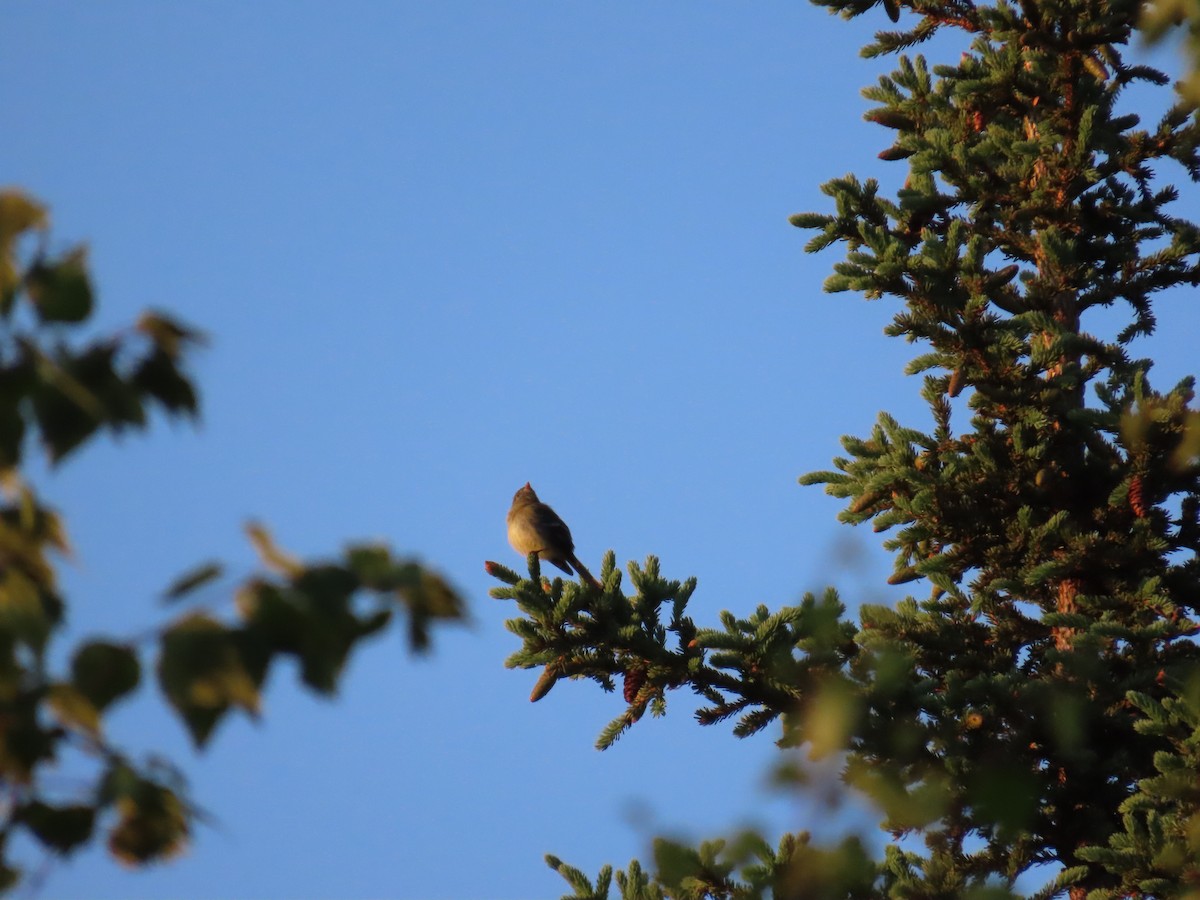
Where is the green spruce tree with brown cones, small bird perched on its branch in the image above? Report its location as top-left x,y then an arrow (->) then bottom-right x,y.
490,0 -> 1200,900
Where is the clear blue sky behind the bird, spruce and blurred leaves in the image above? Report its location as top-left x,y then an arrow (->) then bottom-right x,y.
0,0 -> 1200,900
